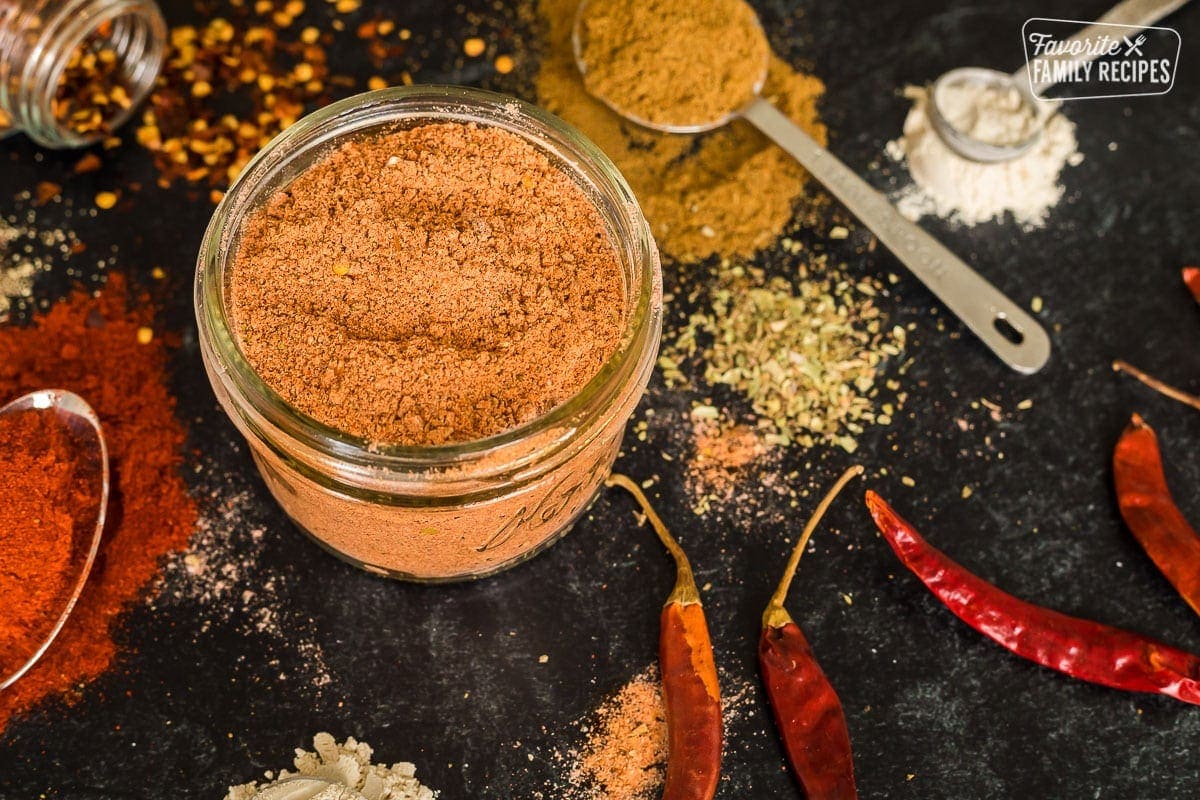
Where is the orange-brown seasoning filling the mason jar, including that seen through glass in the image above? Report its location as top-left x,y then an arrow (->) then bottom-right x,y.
226,121 -> 638,579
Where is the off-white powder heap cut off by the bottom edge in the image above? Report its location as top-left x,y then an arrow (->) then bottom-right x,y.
224,733 -> 437,800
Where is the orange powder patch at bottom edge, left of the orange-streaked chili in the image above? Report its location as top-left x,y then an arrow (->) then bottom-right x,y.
568,670 -> 667,800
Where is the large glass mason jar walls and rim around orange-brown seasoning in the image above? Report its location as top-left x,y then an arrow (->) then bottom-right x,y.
196,86 -> 662,582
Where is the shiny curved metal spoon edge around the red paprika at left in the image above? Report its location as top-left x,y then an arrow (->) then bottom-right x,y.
0,389 -> 108,690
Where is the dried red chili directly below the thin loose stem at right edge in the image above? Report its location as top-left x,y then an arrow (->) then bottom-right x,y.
1112,414 -> 1200,614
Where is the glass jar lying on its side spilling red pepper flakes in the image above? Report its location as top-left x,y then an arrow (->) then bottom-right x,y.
0,0 -> 167,148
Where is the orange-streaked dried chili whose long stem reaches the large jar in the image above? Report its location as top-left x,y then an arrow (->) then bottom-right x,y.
605,475 -> 722,800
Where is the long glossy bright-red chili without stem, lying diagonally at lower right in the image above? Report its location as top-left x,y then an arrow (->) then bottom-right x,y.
866,492 -> 1200,705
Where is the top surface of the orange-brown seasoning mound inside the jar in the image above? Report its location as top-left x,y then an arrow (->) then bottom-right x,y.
229,122 -> 626,446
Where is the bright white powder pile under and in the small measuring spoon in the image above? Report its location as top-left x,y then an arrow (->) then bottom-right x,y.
888,85 -> 1084,228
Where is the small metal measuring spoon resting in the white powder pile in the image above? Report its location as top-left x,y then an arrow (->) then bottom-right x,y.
928,0 -> 1188,163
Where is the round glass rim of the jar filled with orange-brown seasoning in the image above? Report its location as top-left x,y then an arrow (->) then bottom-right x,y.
194,85 -> 662,469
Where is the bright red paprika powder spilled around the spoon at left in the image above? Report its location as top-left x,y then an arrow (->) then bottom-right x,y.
0,275 -> 197,729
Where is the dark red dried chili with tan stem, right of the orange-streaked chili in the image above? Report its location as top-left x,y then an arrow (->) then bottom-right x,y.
758,467 -> 863,800
